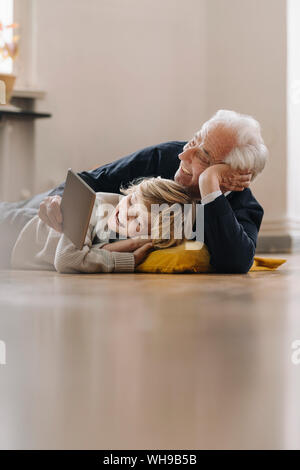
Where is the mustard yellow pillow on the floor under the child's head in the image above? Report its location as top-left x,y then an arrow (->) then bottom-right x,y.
136,242 -> 286,274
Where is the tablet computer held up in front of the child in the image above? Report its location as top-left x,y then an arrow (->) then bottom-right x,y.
61,168 -> 96,250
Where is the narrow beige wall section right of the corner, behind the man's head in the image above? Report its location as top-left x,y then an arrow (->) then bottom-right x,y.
206,0 -> 287,221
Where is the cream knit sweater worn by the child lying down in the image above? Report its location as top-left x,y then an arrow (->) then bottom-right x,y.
11,193 -> 135,273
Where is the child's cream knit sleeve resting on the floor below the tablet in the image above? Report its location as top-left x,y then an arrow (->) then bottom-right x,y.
54,224 -> 135,274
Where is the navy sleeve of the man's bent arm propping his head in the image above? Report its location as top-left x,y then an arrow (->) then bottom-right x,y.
204,190 -> 263,273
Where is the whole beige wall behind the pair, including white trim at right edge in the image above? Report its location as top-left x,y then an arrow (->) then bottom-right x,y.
34,0 -> 300,248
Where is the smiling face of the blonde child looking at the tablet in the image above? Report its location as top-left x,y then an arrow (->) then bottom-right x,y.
108,191 -> 150,238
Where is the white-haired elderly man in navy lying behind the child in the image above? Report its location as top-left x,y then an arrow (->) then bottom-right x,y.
0,111 -> 267,273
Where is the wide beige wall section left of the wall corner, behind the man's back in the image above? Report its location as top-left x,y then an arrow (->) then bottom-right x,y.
35,0 -> 206,191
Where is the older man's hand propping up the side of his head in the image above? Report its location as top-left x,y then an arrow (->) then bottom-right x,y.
199,163 -> 252,197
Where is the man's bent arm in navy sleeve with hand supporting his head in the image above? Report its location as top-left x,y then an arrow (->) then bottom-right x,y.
199,164 -> 263,273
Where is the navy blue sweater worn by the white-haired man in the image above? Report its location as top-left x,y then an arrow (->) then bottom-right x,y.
51,141 -> 264,273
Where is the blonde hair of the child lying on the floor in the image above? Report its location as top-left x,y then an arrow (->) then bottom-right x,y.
121,177 -> 195,248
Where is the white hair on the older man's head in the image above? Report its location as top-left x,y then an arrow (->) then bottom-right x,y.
200,109 -> 268,180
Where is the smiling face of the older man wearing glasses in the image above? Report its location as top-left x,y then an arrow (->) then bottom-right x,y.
174,125 -> 236,197
